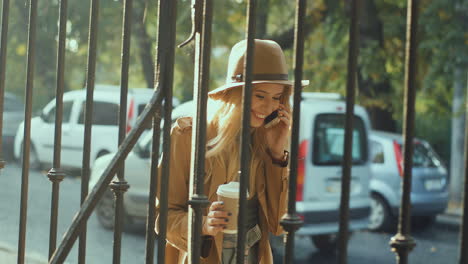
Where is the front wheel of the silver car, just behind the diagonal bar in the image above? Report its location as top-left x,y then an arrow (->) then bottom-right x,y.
96,189 -> 131,229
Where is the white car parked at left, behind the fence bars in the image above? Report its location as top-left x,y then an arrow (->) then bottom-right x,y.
14,85 -> 177,168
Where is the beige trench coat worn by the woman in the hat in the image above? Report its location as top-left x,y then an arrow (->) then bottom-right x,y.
156,117 -> 288,264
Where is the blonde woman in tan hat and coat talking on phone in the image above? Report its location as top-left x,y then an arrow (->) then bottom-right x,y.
156,40 -> 308,263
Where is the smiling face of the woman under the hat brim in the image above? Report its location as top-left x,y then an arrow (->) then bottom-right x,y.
250,83 -> 284,127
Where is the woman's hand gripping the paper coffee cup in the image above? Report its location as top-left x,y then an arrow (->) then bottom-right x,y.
202,201 -> 231,236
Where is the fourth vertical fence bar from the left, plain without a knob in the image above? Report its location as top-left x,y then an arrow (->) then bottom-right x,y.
78,0 -> 99,263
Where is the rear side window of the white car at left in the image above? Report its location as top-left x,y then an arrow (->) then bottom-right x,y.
78,101 -> 119,126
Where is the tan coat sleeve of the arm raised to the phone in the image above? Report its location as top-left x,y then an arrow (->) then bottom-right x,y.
264,154 -> 289,235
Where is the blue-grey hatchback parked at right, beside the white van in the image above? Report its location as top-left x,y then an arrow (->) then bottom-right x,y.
369,131 -> 448,230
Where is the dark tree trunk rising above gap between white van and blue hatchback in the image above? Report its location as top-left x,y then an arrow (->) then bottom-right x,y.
358,0 -> 396,132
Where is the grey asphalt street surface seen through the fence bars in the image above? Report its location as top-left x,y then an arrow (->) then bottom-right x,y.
0,162 -> 459,264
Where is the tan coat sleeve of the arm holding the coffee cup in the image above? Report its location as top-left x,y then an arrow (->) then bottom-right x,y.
155,121 -> 192,251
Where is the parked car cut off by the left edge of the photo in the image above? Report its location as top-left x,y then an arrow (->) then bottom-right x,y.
2,92 -> 24,158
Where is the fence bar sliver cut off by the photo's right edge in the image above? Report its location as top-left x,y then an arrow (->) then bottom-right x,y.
459,81 -> 468,264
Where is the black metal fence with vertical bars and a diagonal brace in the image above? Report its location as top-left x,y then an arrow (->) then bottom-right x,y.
0,0 -> 468,264
